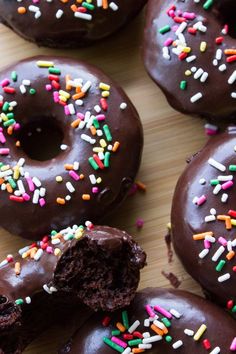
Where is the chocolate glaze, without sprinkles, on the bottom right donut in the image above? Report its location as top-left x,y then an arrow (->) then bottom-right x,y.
59,288 -> 236,354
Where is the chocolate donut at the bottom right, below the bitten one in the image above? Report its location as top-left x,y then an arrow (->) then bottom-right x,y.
60,288 -> 236,354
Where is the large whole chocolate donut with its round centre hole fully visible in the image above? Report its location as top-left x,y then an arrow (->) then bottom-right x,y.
0,57 -> 143,239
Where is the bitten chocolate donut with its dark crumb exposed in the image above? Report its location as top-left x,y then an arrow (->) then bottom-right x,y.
0,223 -> 146,354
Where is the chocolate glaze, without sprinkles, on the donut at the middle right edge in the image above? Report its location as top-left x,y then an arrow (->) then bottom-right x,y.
171,127 -> 236,316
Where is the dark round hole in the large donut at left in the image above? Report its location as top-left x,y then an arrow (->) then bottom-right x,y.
18,118 -> 64,161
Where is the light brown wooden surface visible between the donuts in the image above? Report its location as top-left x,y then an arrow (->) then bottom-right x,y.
0,9 -> 206,354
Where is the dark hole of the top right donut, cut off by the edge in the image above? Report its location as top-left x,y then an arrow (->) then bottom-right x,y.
217,0 -> 236,38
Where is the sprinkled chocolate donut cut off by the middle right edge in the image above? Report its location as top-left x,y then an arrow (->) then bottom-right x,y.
171,127 -> 236,315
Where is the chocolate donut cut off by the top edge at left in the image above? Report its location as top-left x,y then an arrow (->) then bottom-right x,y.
0,0 -> 147,48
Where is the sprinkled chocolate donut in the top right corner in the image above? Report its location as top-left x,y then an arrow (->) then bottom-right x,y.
143,0 -> 236,120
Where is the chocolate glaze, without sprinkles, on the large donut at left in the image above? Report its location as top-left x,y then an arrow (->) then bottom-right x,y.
0,57 -> 143,239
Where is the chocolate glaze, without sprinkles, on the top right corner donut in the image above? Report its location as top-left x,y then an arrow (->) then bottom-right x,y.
143,0 -> 236,120
